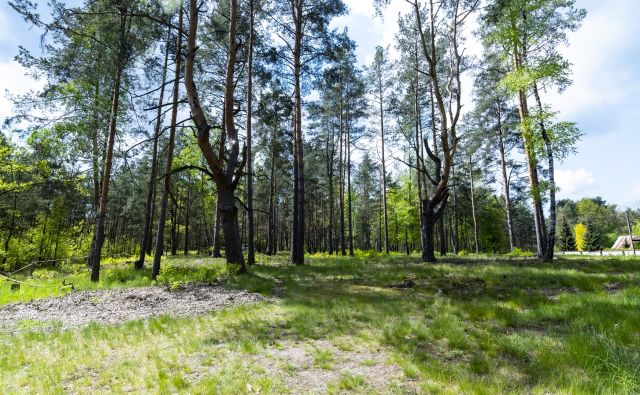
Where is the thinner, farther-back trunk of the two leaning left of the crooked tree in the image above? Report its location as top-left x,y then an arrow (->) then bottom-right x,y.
135,30 -> 171,269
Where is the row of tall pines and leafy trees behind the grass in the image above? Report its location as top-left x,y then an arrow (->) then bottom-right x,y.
0,0 -> 632,280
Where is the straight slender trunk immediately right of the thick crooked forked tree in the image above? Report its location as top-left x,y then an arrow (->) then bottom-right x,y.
247,0 -> 256,266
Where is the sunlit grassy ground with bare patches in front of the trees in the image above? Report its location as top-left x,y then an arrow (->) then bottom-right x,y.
0,254 -> 640,394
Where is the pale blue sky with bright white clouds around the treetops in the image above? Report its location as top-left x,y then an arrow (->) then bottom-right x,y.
0,0 -> 640,208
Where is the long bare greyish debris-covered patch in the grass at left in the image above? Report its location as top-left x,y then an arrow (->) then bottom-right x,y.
0,284 -> 267,331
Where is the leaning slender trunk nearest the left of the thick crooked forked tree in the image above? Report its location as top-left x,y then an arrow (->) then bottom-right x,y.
151,7 -> 182,279
